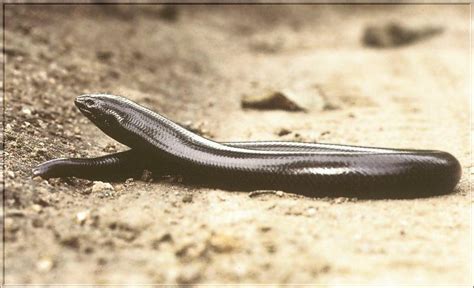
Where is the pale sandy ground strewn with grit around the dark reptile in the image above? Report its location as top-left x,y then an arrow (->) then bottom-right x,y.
4,5 -> 471,285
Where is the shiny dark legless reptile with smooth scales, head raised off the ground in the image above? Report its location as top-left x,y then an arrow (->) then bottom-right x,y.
33,95 -> 461,198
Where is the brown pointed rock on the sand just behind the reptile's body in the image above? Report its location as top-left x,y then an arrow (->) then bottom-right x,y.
241,90 -> 307,111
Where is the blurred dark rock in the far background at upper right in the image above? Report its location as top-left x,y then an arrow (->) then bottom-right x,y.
362,22 -> 443,48
